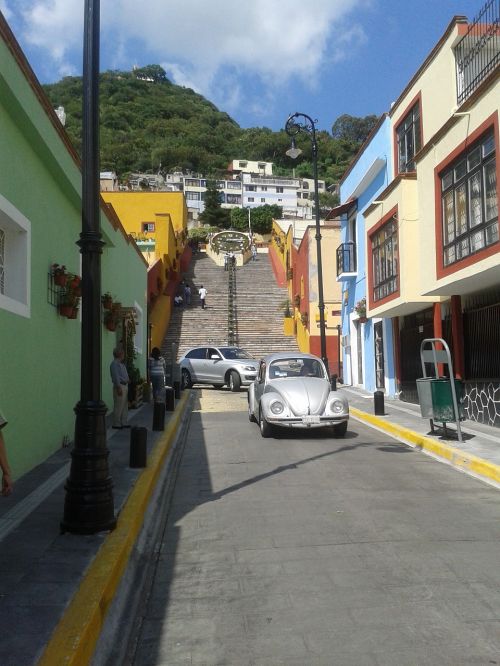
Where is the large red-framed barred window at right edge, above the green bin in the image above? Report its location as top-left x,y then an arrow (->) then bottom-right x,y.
440,132 -> 498,266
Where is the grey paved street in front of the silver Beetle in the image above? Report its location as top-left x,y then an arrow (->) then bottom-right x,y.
128,389 -> 500,666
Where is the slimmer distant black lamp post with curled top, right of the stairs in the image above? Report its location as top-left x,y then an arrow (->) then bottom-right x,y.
285,113 -> 329,372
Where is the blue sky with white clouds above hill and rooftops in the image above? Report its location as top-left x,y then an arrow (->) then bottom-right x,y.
0,0 -> 485,131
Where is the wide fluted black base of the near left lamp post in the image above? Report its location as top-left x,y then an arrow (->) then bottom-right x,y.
61,401 -> 116,534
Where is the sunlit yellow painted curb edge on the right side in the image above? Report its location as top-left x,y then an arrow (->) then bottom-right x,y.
349,407 -> 500,483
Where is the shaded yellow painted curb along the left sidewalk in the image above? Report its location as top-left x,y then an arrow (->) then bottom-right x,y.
38,391 -> 190,666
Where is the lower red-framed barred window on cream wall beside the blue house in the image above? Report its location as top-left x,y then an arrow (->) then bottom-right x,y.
371,215 -> 399,301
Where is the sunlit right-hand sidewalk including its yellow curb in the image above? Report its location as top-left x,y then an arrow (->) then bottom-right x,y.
339,385 -> 500,488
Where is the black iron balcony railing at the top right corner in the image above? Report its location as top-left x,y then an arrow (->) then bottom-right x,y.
455,0 -> 500,106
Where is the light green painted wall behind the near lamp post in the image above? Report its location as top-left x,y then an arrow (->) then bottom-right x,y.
0,16 -> 146,477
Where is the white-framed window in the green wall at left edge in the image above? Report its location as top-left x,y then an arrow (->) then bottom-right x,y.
0,194 -> 31,317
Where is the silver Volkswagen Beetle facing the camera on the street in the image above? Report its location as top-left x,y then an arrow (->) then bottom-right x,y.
248,352 -> 349,437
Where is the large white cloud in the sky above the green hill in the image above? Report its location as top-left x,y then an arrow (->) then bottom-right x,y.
5,0 -> 371,113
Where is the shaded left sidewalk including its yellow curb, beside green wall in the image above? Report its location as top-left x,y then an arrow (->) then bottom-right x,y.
0,391 -> 189,666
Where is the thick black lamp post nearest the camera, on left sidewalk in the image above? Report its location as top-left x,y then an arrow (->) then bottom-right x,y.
61,0 -> 116,534
